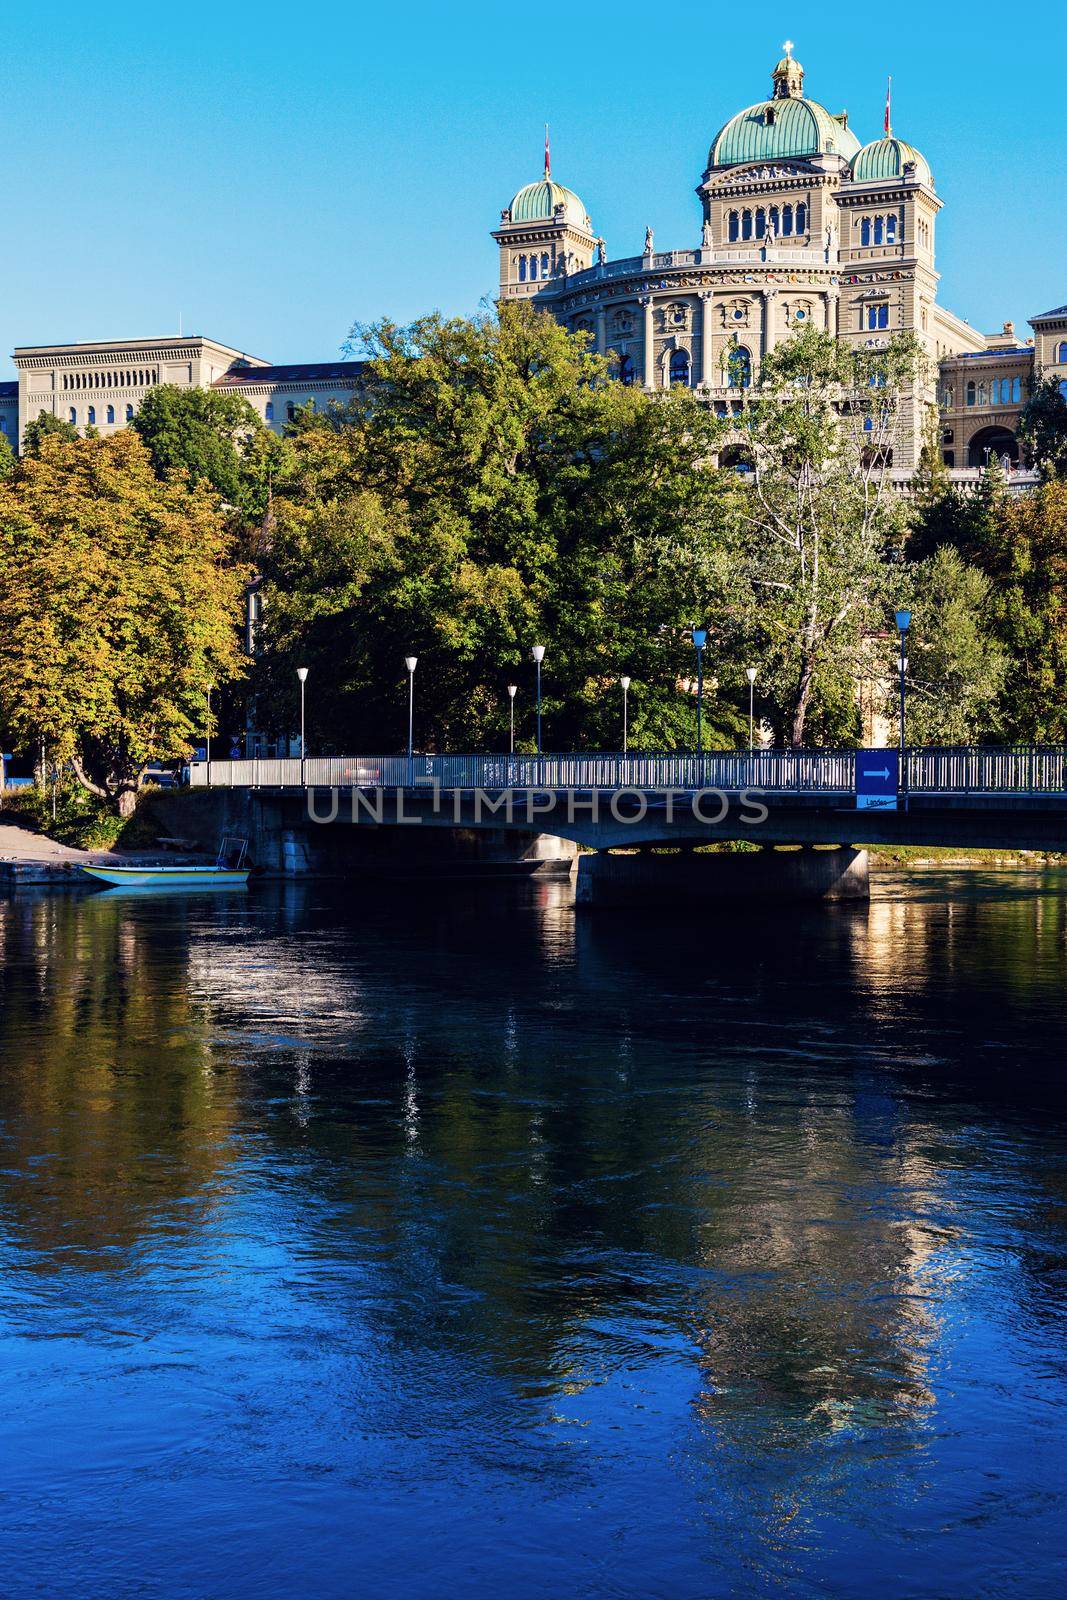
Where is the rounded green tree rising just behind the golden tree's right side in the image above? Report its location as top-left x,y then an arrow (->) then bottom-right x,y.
131,384 -> 285,522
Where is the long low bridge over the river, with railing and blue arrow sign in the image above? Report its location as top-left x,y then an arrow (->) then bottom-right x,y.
190,747 -> 1067,898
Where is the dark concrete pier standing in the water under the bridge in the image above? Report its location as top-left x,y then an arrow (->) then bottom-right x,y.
574,845 -> 870,907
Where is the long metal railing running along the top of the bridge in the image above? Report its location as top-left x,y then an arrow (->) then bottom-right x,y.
189,747 -> 1067,797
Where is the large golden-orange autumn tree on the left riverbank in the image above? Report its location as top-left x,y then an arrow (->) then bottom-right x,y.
0,430 -> 245,814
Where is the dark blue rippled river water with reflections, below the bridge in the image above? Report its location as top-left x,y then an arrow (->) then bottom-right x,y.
0,870 -> 1067,1600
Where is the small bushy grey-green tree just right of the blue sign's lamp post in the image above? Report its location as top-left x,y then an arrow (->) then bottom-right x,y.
886,544 -> 1008,744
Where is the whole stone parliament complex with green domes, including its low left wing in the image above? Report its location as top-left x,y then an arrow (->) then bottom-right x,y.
0,46 -> 1067,475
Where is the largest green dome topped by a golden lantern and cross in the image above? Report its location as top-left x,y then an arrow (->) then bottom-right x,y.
707,54 -> 861,166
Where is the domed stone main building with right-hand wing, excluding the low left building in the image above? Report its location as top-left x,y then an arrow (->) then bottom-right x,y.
493,53 -> 1067,475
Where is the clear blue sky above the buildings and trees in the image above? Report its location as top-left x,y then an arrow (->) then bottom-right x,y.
0,0 -> 1067,374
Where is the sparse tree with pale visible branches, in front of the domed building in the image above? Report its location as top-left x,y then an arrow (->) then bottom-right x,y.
725,328 -> 920,746
